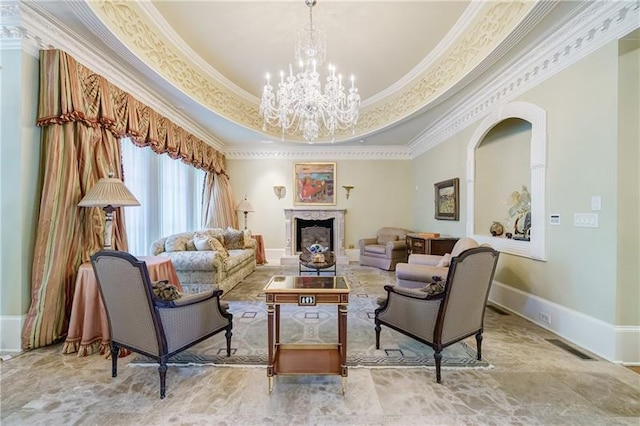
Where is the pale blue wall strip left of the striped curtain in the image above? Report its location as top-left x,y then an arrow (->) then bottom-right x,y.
0,50 -> 40,324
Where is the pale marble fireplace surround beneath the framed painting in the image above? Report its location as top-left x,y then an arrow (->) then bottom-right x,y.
280,208 -> 349,265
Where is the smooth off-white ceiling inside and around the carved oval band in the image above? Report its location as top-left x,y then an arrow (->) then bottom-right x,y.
17,0 -> 628,151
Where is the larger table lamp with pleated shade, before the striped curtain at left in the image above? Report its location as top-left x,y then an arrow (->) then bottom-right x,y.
78,172 -> 140,250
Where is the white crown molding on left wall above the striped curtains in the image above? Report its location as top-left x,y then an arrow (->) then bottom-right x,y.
20,2 -> 224,151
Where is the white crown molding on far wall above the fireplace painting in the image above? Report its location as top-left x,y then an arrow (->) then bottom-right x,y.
224,146 -> 411,161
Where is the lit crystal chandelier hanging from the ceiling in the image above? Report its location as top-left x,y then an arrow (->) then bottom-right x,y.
260,0 -> 360,141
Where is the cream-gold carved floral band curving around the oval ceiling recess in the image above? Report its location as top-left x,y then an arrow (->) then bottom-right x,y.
87,0 -> 536,143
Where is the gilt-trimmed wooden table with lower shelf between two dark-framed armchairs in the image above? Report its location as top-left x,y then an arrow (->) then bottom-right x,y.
264,276 -> 351,394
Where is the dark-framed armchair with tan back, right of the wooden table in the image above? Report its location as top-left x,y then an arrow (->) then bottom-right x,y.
375,247 -> 499,383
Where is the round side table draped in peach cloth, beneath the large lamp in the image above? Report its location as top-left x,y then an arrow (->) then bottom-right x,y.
62,256 -> 182,357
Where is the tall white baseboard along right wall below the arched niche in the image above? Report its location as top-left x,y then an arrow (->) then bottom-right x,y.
489,281 -> 640,365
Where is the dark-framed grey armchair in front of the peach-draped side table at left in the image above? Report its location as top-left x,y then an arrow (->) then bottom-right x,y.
91,250 -> 233,398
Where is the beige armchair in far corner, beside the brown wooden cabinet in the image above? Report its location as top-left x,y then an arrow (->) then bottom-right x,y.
359,227 -> 411,271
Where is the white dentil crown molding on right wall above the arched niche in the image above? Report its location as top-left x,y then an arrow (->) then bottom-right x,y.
408,0 -> 640,158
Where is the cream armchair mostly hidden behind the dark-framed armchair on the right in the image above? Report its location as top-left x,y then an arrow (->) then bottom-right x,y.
396,238 -> 478,288
